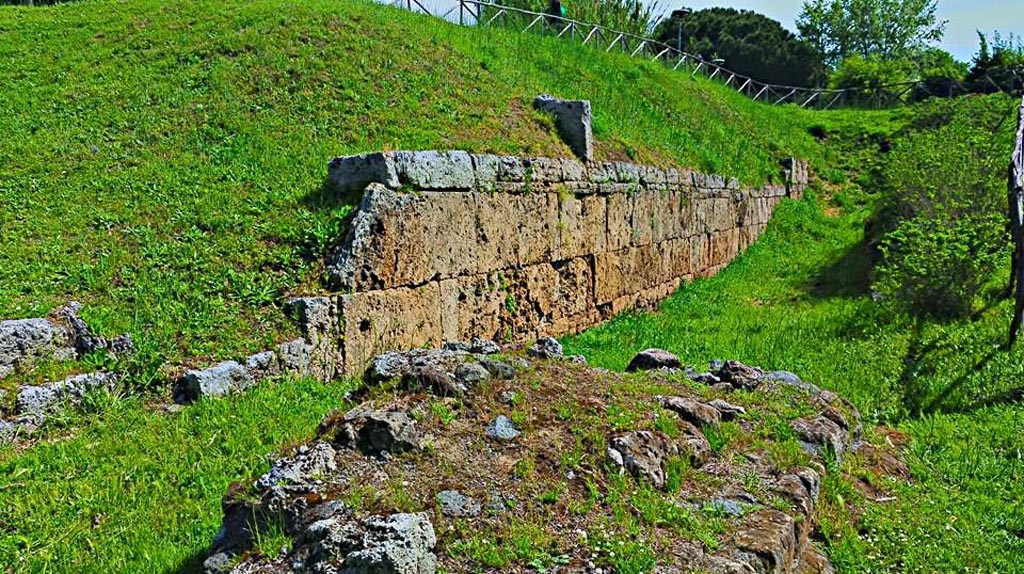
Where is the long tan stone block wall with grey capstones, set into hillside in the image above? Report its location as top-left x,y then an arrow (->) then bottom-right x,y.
315,151 -> 807,374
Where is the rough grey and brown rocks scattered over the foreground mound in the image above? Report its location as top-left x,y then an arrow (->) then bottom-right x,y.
205,342 -> 876,574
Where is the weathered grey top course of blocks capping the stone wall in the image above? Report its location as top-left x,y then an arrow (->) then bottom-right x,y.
328,150 -> 807,193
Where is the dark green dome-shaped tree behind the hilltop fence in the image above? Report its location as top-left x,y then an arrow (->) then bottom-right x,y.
654,8 -> 824,86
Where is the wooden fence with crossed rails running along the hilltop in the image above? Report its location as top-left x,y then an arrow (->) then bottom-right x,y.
383,0 -> 1024,109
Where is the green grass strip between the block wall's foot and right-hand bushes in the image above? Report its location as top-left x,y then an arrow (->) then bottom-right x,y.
564,190 -> 1024,573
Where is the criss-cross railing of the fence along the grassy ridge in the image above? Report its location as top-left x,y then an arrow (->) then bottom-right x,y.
384,0 -> 1022,109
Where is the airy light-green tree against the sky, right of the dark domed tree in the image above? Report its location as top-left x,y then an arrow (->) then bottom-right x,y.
797,0 -> 946,68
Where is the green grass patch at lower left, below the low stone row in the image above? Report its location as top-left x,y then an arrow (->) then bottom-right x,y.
0,381 -> 349,573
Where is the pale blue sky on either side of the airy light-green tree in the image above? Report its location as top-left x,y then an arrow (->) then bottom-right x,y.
658,0 -> 1024,61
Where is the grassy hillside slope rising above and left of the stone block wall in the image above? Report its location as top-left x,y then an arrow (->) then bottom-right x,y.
0,0 -> 856,384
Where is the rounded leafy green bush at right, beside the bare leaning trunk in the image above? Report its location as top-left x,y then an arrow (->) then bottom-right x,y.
876,96 -> 1016,318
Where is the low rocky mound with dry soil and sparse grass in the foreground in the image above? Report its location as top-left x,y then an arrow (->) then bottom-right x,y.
205,340 -> 905,574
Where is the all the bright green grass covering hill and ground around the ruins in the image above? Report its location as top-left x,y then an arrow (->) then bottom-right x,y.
0,0 -> 1024,573
